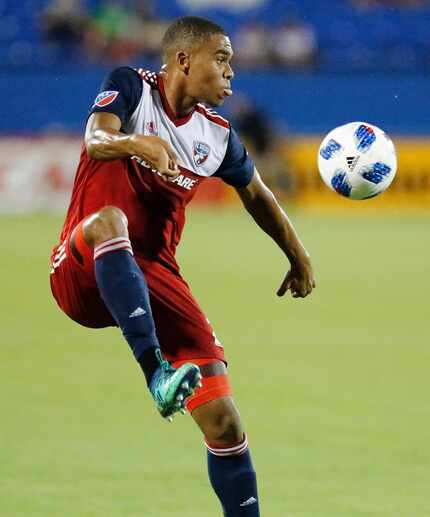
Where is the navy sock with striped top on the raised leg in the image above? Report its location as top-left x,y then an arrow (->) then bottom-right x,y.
94,237 -> 160,384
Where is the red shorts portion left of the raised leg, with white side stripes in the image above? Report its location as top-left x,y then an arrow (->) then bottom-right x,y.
50,221 -> 115,328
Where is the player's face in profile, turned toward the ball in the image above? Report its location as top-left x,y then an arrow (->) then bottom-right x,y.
188,34 -> 234,106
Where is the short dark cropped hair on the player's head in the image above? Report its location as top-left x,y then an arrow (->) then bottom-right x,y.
161,16 -> 227,60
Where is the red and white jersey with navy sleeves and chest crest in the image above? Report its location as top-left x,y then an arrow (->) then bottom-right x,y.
55,67 -> 254,271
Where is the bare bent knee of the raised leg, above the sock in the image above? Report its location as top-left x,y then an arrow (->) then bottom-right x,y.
83,206 -> 128,246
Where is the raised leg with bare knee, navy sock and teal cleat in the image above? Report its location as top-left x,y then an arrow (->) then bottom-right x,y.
49,206 -> 200,418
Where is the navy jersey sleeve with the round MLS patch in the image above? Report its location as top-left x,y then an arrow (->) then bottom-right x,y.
89,66 -> 143,125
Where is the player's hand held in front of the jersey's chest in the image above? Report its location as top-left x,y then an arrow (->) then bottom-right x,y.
130,135 -> 179,181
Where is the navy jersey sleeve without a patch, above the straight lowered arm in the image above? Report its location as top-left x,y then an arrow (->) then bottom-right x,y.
214,127 -> 254,188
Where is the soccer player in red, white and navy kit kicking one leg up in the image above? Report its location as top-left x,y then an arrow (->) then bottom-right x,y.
51,17 -> 315,517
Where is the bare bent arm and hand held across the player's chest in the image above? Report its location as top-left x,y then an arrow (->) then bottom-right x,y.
85,112 -> 179,179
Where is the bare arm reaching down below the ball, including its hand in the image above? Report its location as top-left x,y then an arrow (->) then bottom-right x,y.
236,169 -> 315,298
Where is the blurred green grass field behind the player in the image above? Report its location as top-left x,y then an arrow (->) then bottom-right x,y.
0,211 -> 430,517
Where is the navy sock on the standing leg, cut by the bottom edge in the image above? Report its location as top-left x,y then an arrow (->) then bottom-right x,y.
206,437 -> 260,517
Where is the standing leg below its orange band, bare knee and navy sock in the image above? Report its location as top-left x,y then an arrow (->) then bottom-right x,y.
192,390 -> 260,517
